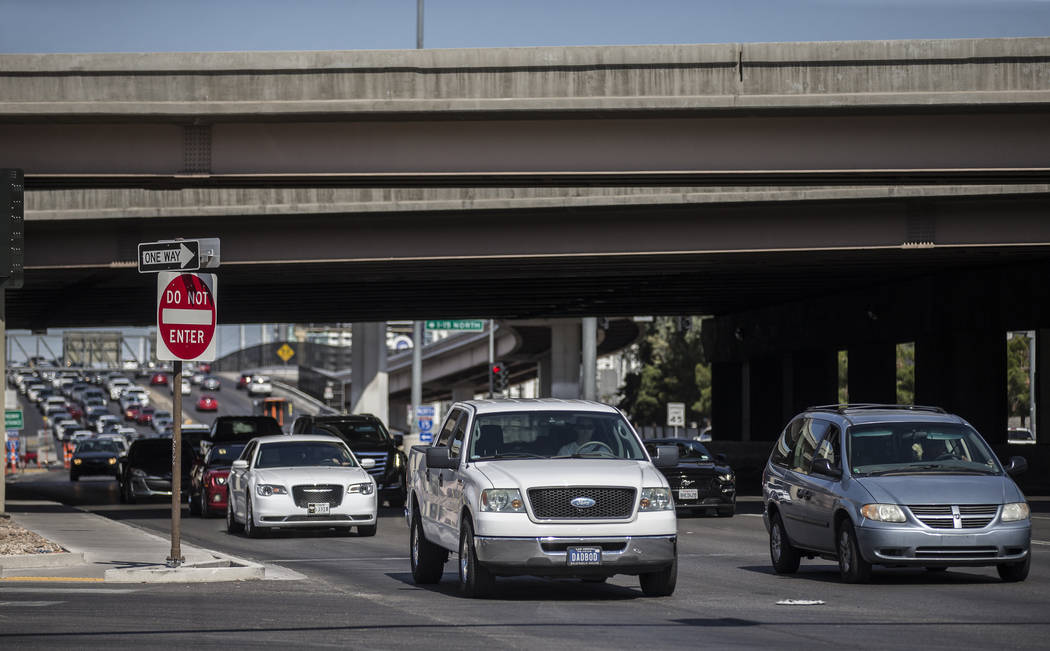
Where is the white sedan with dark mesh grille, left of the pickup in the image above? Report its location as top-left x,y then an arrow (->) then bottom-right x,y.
226,435 -> 377,538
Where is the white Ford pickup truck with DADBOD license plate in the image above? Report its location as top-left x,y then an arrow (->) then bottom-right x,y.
405,399 -> 678,596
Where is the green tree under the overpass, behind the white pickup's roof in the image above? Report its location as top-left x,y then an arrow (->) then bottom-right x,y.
618,317 -> 711,425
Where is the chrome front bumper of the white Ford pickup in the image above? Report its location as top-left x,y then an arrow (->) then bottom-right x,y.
474,536 -> 677,576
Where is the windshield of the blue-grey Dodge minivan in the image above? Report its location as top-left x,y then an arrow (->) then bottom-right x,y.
846,422 -> 1003,475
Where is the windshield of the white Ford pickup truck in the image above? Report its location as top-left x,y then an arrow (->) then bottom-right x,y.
469,412 -> 646,461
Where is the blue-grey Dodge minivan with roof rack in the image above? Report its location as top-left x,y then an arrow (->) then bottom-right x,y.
762,404 -> 1031,583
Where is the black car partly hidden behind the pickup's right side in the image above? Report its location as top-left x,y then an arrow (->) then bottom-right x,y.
646,439 -> 736,518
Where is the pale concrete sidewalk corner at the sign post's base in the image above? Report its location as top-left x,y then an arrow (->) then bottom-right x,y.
0,500 -> 270,583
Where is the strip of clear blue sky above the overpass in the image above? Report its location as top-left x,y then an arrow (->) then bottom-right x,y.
0,0 -> 1050,53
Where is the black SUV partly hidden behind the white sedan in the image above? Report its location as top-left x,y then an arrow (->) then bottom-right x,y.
292,414 -> 406,506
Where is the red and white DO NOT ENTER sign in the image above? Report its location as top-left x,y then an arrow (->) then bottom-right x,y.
156,271 -> 217,361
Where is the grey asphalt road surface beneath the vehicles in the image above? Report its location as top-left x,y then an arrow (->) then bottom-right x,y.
0,473 -> 1050,649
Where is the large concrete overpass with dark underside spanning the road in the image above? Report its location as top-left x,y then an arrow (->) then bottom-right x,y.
0,38 -> 1050,453
